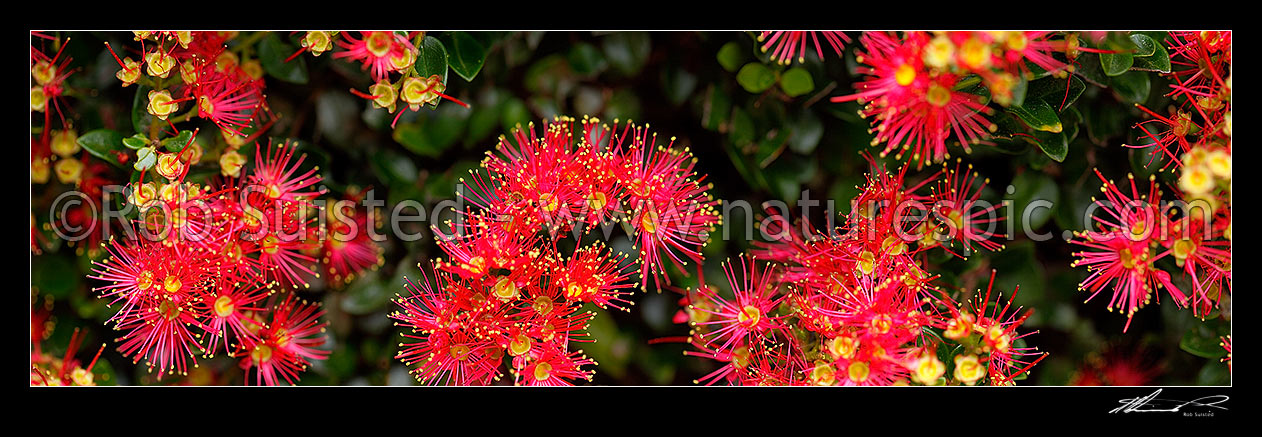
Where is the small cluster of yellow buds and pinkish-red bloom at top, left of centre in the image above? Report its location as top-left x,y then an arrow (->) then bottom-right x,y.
290,30 -> 469,126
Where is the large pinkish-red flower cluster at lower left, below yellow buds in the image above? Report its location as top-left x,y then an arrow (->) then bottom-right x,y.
90,135 -> 380,385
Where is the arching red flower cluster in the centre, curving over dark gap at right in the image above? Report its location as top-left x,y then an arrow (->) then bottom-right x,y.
390,117 -> 719,385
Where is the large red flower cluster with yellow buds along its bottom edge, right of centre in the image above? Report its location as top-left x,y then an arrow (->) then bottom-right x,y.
676,157 -> 1045,385
